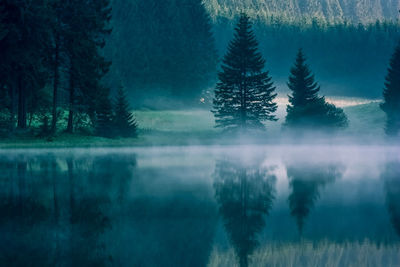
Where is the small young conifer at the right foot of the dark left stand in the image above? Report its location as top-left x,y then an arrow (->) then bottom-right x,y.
114,86 -> 137,137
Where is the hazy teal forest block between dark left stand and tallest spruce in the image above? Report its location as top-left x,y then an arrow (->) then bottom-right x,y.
107,0 -> 217,107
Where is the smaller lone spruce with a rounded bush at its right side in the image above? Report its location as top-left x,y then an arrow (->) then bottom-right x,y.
285,49 -> 348,129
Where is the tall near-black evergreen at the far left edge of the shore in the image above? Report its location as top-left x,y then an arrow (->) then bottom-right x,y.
0,0 -> 50,129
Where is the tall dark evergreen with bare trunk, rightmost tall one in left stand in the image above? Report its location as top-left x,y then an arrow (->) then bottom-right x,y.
65,0 -> 111,132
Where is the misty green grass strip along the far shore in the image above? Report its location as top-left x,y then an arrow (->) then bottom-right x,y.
0,100 -> 385,148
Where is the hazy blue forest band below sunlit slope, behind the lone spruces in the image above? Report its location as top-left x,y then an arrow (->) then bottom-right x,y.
215,17 -> 400,98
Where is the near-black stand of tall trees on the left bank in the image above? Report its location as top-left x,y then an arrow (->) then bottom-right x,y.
0,0 -> 136,136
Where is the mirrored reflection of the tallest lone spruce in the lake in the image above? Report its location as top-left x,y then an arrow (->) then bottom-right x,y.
214,161 -> 276,267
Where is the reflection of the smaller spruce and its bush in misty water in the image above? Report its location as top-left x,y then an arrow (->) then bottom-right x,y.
287,164 -> 343,234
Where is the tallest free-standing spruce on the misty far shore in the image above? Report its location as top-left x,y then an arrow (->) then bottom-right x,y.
212,13 -> 277,131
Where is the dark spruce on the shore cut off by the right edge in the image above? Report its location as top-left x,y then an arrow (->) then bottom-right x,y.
381,44 -> 400,136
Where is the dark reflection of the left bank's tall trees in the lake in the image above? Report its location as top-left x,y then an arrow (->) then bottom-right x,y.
0,155 -> 136,266
